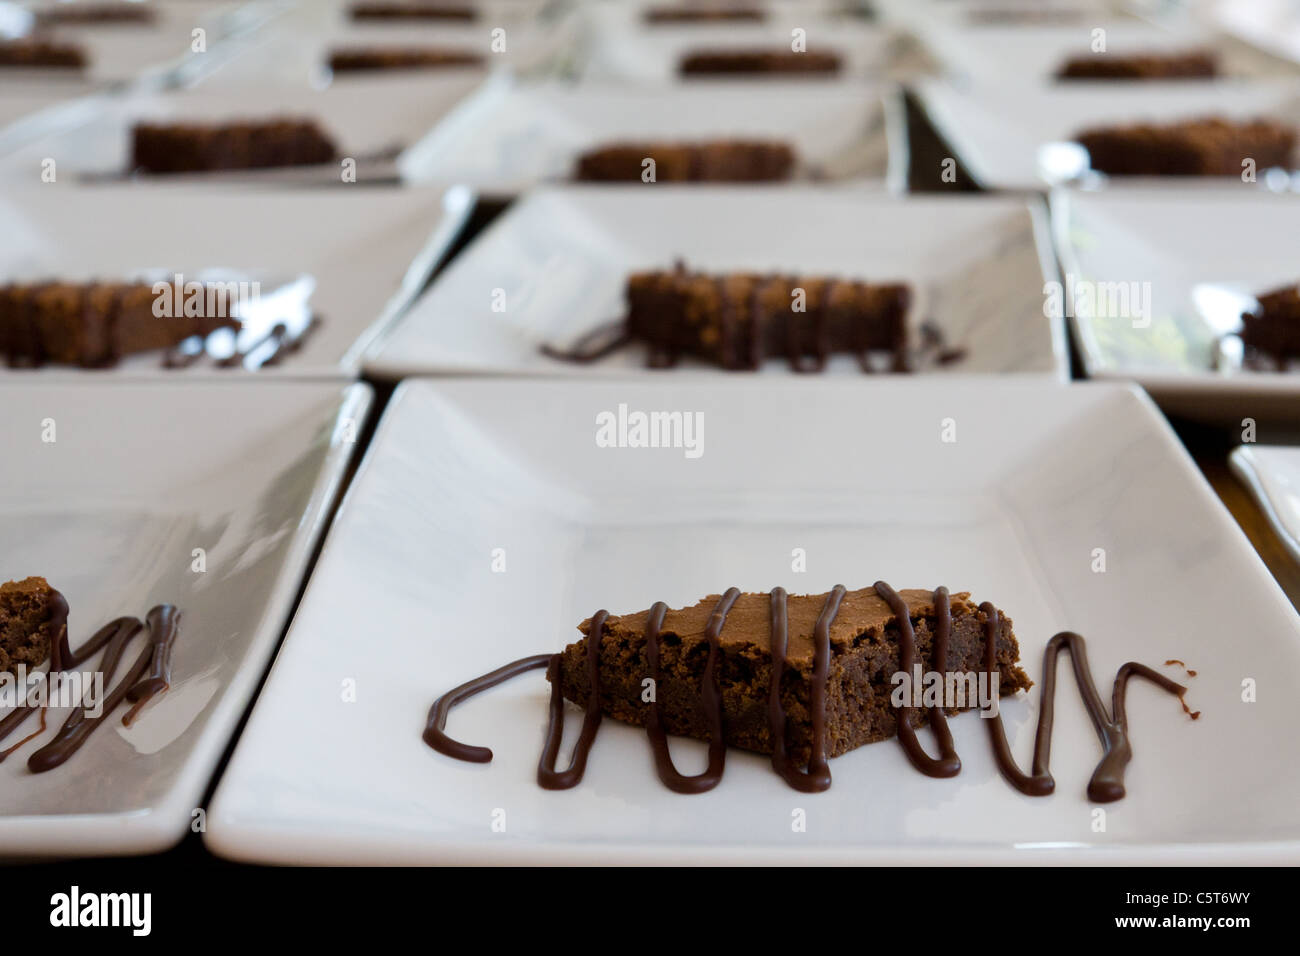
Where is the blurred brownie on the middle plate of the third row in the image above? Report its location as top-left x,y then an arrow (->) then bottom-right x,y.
575,140 -> 794,182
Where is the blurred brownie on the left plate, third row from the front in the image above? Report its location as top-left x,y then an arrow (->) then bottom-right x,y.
131,118 -> 338,173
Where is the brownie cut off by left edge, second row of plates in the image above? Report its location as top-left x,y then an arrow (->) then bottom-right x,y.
0,282 -> 239,368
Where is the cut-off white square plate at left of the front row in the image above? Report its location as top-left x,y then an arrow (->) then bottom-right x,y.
0,381 -> 371,858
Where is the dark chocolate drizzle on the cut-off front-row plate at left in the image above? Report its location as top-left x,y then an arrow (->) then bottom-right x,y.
0,591 -> 181,774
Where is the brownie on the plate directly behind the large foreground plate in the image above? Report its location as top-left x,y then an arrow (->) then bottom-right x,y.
627,268 -> 911,368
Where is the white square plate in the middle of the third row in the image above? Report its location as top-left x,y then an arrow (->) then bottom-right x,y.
398,74 -> 905,195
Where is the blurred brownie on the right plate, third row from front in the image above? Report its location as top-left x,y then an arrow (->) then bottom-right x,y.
1075,117 -> 1296,176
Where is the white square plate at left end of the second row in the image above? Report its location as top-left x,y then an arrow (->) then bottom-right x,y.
0,182 -> 472,381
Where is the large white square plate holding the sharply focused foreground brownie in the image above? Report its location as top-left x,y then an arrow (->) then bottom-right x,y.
205,378 -> 1300,864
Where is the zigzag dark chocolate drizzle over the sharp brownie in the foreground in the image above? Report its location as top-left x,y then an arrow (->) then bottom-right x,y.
424,581 -> 1199,803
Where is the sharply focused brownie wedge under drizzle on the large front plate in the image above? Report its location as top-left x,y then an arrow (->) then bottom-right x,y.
547,588 -> 1032,762
